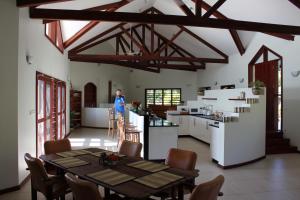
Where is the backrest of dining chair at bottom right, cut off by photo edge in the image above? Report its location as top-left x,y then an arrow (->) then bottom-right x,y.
190,175 -> 225,200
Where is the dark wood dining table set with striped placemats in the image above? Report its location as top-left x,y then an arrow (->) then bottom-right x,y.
40,148 -> 198,200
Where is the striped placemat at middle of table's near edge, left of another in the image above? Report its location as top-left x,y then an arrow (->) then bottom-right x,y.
87,169 -> 135,186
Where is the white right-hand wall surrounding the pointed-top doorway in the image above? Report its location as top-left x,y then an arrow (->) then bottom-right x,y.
197,33 -> 300,149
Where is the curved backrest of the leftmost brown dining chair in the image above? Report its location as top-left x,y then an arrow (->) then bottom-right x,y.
24,153 -> 49,192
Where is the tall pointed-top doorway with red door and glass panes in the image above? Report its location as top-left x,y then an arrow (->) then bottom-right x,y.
248,45 -> 283,133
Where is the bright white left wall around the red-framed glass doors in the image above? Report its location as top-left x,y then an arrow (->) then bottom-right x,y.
18,8 -> 69,183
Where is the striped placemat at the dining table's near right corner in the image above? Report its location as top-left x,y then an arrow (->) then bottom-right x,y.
134,171 -> 183,189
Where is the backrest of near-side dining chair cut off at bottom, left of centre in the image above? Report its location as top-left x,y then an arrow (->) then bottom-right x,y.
65,173 -> 102,200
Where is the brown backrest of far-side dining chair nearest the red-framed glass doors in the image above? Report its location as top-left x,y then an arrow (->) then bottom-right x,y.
44,139 -> 72,155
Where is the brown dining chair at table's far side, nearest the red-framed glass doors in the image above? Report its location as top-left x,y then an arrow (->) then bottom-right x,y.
44,138 -> 72,175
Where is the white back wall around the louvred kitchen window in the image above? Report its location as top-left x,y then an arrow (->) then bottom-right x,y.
130,69 -> 197,105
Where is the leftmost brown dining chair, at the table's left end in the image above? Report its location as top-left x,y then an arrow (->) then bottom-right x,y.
24,153 -> 69,200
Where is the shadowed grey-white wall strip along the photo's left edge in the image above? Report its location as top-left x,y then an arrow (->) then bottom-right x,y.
0,0 -> 18,190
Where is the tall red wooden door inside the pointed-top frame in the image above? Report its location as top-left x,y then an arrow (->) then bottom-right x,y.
255,61 -> 278,131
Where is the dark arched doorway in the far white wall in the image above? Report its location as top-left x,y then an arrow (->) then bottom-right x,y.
84,83 -> 97,108
